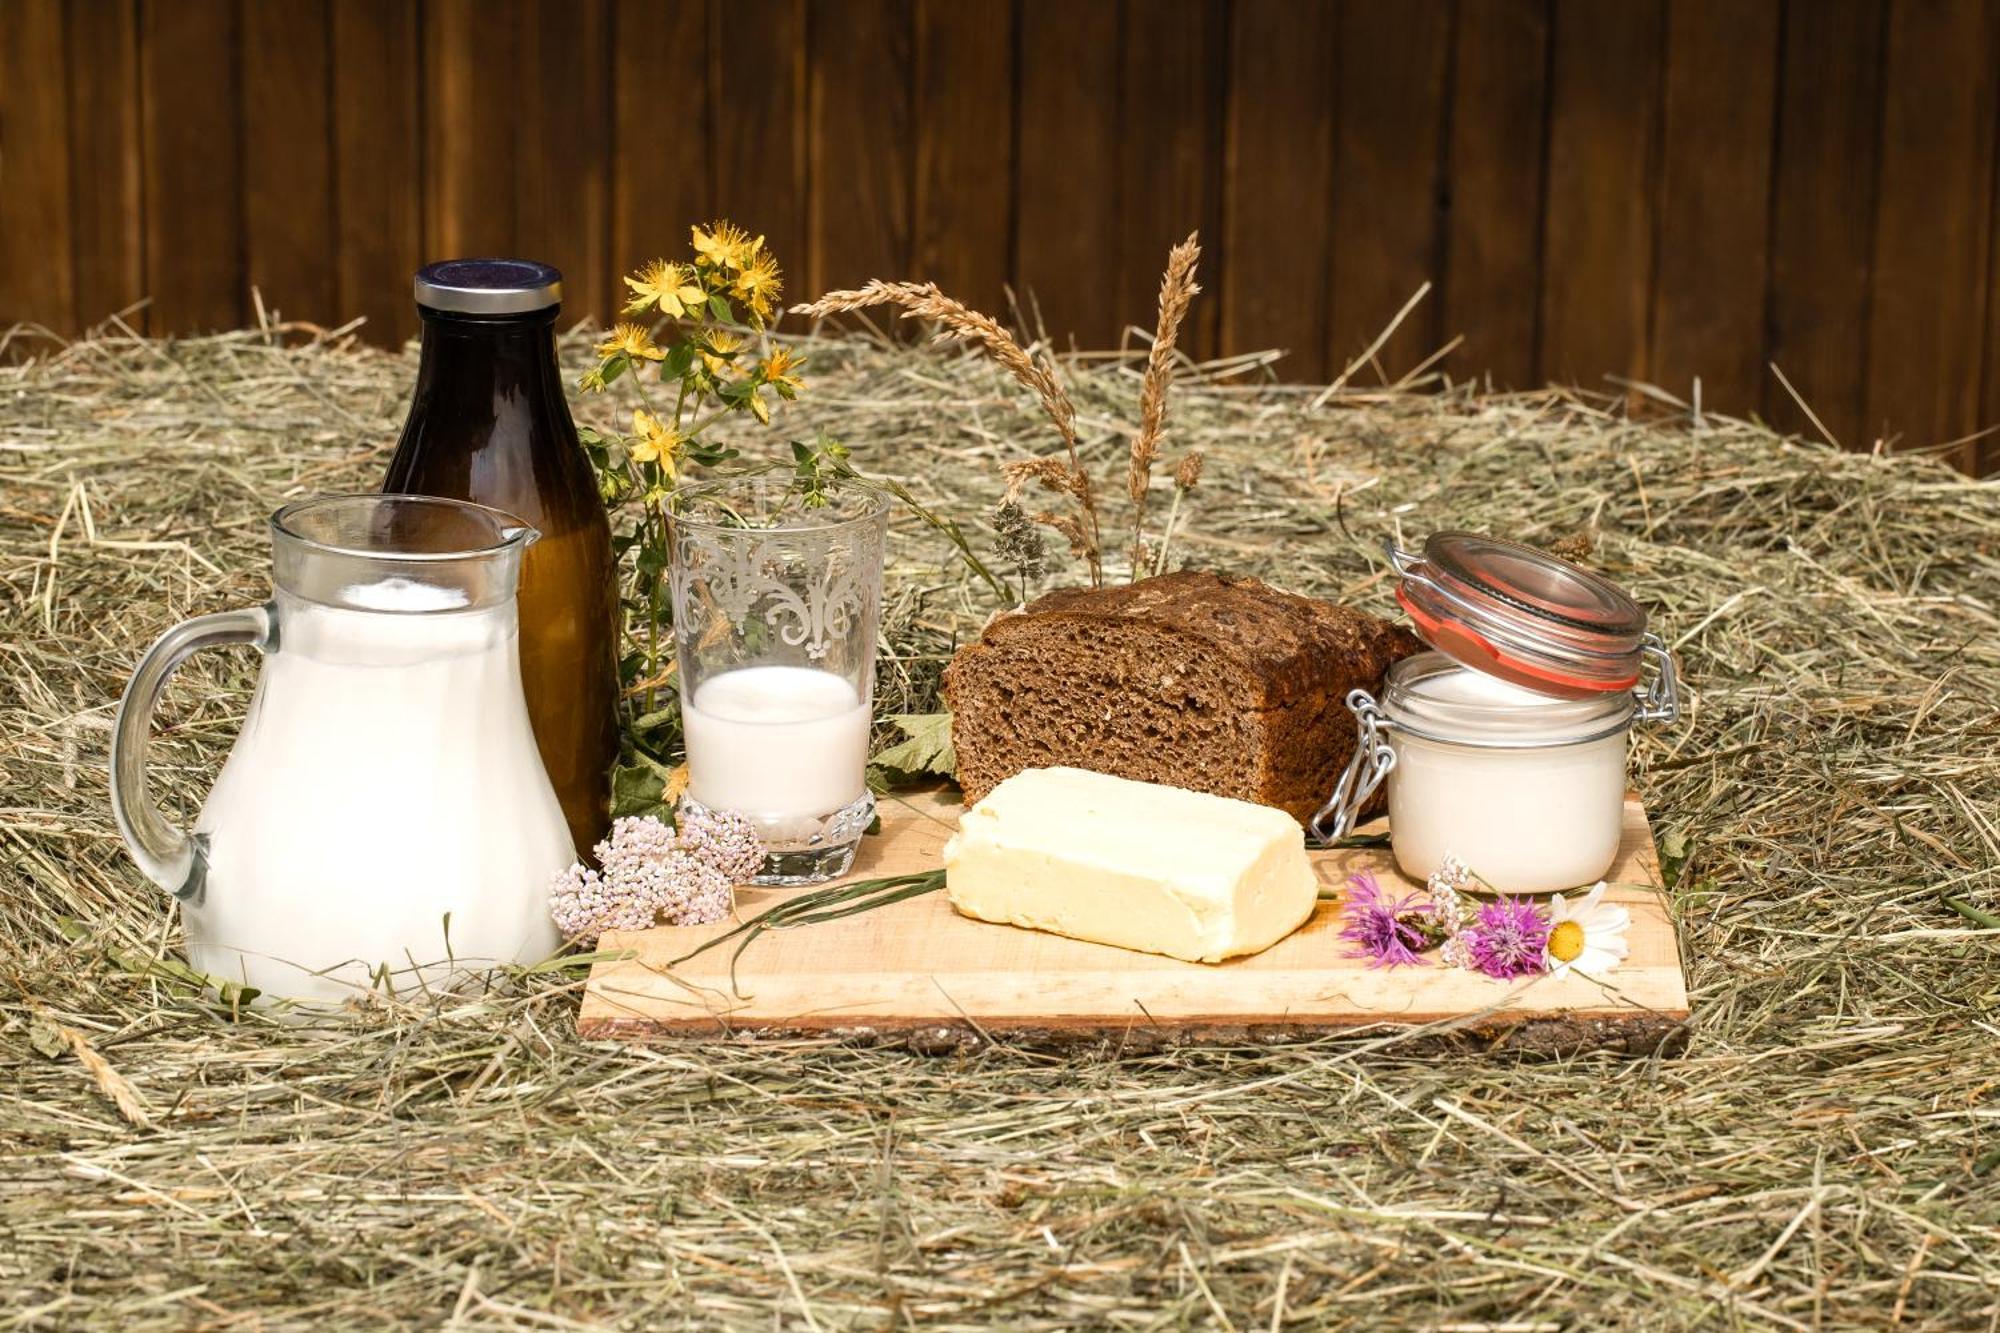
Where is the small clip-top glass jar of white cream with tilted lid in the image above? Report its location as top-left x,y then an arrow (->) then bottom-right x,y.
1312,532 -> 1680,893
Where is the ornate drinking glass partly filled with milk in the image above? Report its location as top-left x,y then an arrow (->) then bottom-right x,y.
668,470 -> 888,885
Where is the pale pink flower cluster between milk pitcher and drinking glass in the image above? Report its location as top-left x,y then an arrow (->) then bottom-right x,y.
548,811 -> 764,945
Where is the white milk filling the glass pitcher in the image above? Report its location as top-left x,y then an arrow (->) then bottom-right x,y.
184,578 -> 574,999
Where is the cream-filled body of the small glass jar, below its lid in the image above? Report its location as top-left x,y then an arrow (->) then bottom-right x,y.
1380,652 -> 1636,893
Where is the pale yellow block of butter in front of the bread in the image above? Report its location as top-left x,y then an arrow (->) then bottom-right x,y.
944,769 -> 1318,963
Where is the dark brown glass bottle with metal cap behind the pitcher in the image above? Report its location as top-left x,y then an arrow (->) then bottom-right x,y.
382,260 -> 618,853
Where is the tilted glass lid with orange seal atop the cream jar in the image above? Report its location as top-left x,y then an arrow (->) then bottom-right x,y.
1390,532 -> 1646,699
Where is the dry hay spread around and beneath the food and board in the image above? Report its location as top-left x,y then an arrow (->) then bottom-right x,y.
0,316 -> 2000,1329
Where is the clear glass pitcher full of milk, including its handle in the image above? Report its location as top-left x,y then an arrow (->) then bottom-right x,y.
112,494 -> 576,1001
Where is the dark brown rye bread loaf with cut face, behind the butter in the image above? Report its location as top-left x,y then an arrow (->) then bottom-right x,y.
944,572 -> 1422,823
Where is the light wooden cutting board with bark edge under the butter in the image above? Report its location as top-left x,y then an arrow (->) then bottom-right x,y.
576,793 -> 1688,1049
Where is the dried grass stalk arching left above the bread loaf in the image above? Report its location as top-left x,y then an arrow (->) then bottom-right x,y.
792,278 -> 1104,586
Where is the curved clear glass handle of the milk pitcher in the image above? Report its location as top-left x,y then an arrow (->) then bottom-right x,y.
112,606 -> 274,901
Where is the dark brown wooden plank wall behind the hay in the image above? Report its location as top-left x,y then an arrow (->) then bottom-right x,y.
0,0 -> 2000,470
